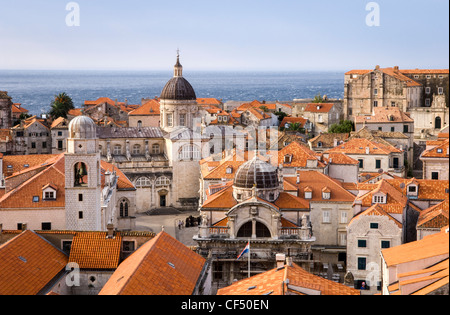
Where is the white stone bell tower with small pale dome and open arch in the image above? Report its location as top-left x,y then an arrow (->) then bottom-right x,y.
65,116 -> 106,231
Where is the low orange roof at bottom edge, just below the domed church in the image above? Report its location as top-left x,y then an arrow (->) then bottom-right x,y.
217,263 -> 360,295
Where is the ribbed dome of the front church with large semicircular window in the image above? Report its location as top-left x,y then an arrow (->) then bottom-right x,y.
234,157 -> 279,189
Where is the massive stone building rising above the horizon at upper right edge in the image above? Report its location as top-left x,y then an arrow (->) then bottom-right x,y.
344,66 -> 449,138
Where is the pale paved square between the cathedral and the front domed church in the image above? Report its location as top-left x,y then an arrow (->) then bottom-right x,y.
135,211 -> 200,246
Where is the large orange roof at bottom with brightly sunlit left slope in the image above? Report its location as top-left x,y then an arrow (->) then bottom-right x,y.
99,231 -> 206,295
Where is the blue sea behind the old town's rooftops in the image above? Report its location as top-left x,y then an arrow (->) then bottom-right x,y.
0,70 -> 344,116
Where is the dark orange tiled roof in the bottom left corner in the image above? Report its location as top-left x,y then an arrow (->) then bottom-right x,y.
0,230 -> 68,295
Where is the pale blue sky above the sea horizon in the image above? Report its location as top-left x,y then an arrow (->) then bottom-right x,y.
0,0 -> 449,71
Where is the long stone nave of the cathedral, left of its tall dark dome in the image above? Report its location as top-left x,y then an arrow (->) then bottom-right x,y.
97,127 -> 173,213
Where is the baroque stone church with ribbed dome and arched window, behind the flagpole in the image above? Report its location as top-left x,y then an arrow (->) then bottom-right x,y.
194,156 -> 314,292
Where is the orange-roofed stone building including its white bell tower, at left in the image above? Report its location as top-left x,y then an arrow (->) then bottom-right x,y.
0,116 -> 136,231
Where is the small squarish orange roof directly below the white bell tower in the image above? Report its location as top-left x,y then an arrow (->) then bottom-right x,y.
69,232 -> 122,269
